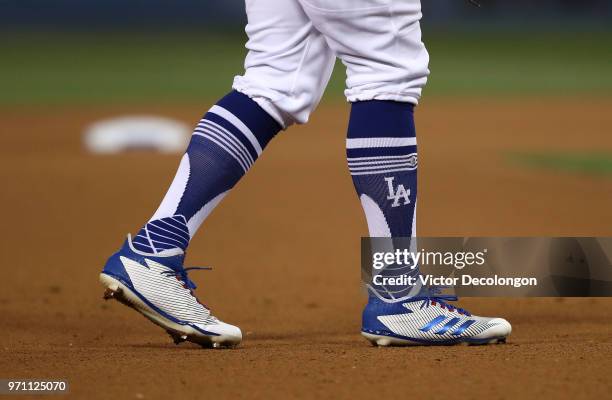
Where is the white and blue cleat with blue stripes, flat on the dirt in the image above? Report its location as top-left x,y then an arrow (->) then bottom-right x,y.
361,294 -> 512,346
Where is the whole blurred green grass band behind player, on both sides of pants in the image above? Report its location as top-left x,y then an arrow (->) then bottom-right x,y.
0,32 -> 612,105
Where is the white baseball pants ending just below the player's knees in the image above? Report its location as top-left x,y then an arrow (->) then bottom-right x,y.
233,0 -> 429,128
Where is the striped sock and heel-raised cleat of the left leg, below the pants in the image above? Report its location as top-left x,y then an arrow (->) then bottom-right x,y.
100,91 -> 281,346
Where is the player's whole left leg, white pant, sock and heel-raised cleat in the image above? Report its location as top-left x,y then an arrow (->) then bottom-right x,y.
100,0 -> 334,346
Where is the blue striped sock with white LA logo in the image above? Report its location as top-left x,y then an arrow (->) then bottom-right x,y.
346,100 -> 419,300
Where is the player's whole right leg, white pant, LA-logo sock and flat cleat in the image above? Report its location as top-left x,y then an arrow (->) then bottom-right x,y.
300,0 -> 511,345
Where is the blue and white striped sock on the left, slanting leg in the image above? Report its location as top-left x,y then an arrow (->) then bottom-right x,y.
133,91 -> 281,253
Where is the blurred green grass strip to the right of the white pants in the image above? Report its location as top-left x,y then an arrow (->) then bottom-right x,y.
429,32 -> 612,96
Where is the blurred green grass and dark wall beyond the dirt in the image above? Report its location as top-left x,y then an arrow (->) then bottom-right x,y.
0,0 -> 612,105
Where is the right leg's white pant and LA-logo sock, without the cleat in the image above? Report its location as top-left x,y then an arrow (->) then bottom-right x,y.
301,0 -> 429,299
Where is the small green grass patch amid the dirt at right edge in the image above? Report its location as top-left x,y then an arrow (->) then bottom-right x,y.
508,153 -> 612,177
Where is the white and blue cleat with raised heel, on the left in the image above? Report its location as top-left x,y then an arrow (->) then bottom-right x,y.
100,235 -> 242,348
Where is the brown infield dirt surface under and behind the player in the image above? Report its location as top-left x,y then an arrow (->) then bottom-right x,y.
0,99 -> 612,399
